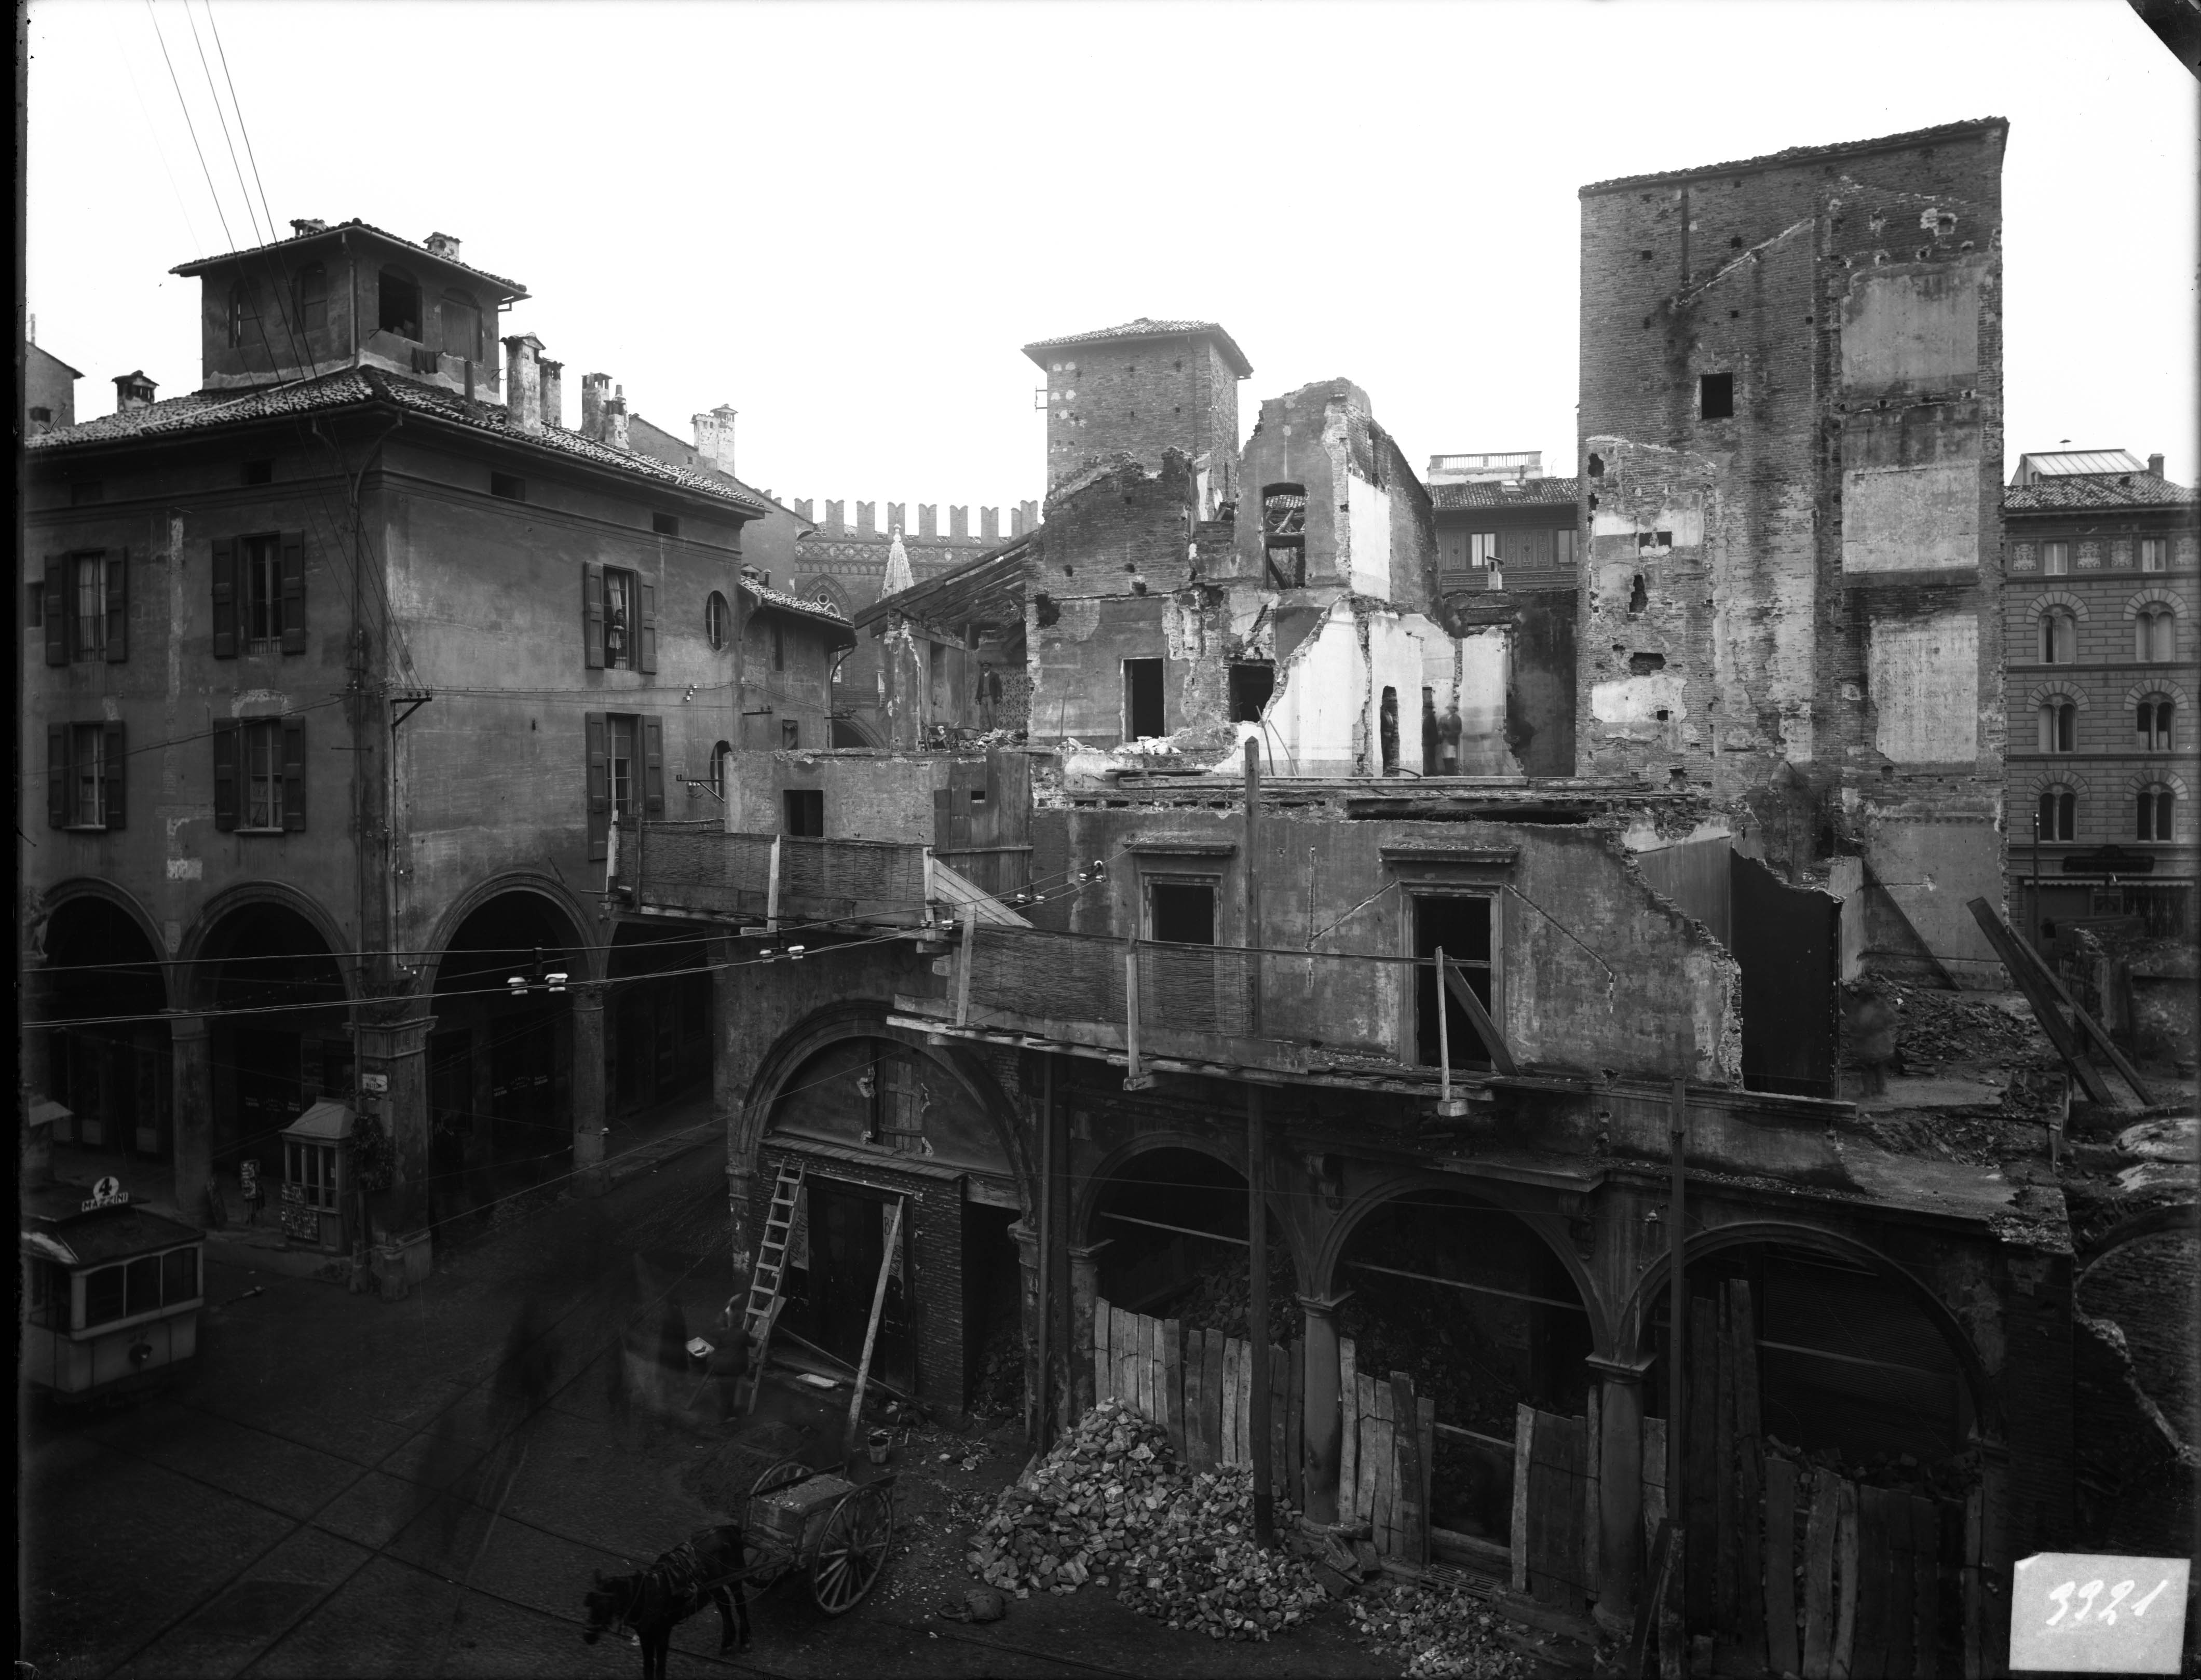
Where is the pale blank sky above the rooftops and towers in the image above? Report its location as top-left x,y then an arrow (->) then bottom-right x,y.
26,0 -> 2201,513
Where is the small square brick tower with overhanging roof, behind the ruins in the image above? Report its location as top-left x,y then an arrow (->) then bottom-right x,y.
1024,315 -> 1253,515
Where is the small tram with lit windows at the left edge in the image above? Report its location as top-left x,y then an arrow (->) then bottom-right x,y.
18,1178 -> 205,1407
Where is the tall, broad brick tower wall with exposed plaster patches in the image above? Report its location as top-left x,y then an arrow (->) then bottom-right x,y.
1576,121 -> 2005,984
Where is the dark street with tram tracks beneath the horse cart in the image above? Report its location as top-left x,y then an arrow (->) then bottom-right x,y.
18,1149 -> 1382,1680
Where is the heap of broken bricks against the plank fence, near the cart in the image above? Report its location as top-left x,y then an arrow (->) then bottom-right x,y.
966,1400 -> 1323,1641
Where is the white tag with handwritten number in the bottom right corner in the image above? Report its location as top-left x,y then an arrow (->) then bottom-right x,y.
2009,1552 -> 2192,1673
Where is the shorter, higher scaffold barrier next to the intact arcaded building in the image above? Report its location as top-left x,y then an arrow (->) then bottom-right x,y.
618,823 -> 927,927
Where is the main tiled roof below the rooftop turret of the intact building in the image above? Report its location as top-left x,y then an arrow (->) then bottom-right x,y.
24,368 -> 764,513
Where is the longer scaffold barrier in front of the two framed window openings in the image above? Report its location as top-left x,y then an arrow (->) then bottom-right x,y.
896,923 -> 1444,1081
